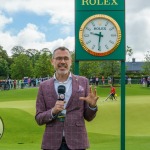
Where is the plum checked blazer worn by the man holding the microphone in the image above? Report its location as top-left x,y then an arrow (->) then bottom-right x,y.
35,74 -> 97,150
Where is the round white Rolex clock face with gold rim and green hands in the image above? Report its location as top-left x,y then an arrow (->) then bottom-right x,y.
79,14 -> 121,56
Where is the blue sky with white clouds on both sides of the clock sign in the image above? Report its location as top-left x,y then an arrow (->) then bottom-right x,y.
0,0 -> 150,61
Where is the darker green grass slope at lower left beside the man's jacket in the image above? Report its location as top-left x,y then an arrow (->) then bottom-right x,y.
0,108 -> 43,150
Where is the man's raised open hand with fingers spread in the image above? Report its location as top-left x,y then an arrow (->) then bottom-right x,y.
79,86 -> 99,108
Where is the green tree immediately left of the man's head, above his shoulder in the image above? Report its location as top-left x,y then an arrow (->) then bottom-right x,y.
34,53 -> 54,77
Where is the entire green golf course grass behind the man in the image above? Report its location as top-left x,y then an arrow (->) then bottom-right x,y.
0,84 -> 150,150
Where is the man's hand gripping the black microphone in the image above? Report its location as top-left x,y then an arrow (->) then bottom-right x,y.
52,100 -> 65,115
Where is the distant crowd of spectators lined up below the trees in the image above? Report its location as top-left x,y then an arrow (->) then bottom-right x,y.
0,76 -> 150,90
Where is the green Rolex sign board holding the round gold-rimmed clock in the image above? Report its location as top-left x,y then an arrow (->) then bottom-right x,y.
75,0 -> 125,61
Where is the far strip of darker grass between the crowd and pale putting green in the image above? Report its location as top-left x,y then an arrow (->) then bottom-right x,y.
0,84 -> 150,102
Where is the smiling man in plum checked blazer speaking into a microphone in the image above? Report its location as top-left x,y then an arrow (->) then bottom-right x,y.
35,47 -> 99,150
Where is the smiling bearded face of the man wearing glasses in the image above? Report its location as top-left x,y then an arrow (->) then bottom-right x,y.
52,50 -> 72,75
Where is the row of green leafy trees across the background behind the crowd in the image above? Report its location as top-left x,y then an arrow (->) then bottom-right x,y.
0,46 -> 150,79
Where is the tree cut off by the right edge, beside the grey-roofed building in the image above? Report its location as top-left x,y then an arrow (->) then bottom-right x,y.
142,51 -> 150,75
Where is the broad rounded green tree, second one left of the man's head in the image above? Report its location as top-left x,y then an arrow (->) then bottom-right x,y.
11,54 -> 33,79
